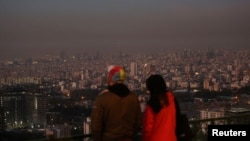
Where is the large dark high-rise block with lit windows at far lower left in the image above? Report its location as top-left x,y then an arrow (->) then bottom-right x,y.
0,92 -> 47,129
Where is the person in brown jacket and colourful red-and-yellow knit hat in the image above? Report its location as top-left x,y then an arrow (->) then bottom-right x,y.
91,65 -> 142,141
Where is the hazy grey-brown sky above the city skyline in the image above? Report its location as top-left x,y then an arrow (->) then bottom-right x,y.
0,0 -> 250,58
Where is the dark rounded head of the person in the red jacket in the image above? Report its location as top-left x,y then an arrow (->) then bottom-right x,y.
146,74 -> 167,93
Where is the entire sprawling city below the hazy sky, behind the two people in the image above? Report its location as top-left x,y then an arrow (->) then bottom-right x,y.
0,49 -> 250,138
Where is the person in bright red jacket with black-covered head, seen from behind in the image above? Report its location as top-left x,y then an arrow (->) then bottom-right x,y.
142,74 -> 179,141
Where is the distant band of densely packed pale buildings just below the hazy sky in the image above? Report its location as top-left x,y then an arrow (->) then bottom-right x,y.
0,49 -> 250,93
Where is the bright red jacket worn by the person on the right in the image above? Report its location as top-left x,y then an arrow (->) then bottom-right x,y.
142,92 -> 177,141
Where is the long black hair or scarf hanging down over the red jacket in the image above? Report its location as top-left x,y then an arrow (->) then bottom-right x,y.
146,74 -> 168,113
